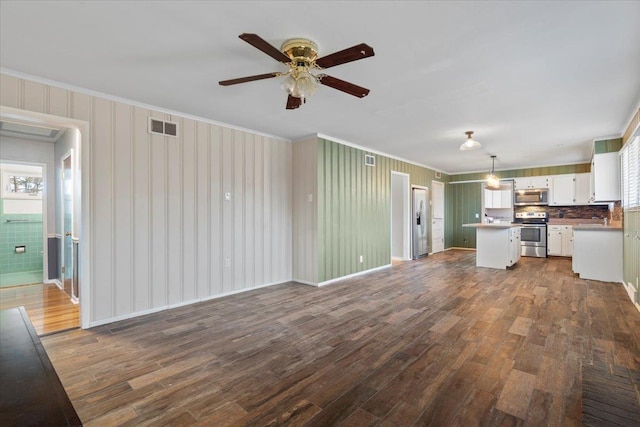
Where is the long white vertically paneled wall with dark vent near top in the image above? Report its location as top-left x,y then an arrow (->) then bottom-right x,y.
0,74 -> 292,325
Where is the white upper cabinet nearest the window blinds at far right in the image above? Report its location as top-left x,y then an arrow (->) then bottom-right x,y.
591,152 -> 620,202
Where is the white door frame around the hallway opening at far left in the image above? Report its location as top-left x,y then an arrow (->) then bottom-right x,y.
0,105 -> 92,329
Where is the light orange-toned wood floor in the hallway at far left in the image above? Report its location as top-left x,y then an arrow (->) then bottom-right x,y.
0,283 -> 80,335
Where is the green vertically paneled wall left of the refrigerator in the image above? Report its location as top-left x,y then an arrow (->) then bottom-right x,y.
317,138 -> 449,282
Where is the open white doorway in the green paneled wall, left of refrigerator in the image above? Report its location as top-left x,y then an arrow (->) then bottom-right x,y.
391,171 -> 411,261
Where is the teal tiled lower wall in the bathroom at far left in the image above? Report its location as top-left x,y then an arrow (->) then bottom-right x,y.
0,198 -> 42,273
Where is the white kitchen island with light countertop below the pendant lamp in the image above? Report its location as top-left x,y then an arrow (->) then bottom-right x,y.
462,222 -> 520,270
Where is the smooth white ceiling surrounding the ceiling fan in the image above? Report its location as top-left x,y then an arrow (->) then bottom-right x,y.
0,0 -> 640,173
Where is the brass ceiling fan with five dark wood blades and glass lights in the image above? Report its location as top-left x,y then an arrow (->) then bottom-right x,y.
219,33 -> 374,110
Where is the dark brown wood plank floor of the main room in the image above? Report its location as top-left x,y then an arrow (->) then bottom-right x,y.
42,251 -> 640,426
